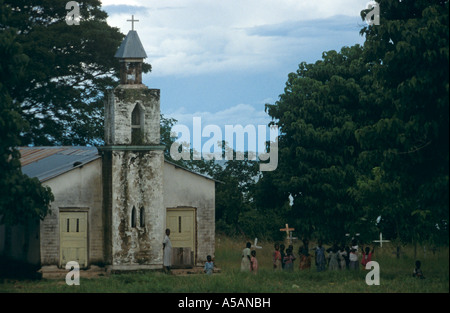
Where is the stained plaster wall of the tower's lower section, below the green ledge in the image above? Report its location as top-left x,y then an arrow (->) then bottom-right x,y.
111,151 -> 165,266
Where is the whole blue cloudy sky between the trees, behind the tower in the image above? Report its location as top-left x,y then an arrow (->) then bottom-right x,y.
102,0 -> 368,145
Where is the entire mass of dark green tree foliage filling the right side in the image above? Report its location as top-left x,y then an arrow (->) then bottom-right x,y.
260,0 -> 449,242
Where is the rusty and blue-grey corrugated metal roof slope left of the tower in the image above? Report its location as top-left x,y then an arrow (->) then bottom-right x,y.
19,146 -> 101,182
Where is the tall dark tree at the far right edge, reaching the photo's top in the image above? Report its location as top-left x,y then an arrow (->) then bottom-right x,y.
357,0 -> 449,242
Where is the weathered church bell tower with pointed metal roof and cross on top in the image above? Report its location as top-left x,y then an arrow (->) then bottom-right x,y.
99,16 -> 165,270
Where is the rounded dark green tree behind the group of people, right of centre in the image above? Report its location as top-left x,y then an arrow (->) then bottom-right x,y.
263,45 -> 376,240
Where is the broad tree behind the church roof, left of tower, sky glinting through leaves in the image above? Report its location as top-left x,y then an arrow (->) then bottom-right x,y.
0,0 -> 151,145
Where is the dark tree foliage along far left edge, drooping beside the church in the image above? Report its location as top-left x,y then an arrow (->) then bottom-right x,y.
0,0 -> 53,225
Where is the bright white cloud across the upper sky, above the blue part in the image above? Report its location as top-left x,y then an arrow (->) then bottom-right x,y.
103,0 -> 366,77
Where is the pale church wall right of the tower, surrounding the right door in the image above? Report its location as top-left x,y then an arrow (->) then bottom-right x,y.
164,162 -> 215,265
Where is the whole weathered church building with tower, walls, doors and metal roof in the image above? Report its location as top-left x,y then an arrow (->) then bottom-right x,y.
0,30 -> 216,270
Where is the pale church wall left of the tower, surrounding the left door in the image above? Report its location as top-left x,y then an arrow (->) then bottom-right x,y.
40,159 -> 104,265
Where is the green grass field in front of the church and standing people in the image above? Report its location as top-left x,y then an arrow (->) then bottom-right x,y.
0,237 -> 449,293
